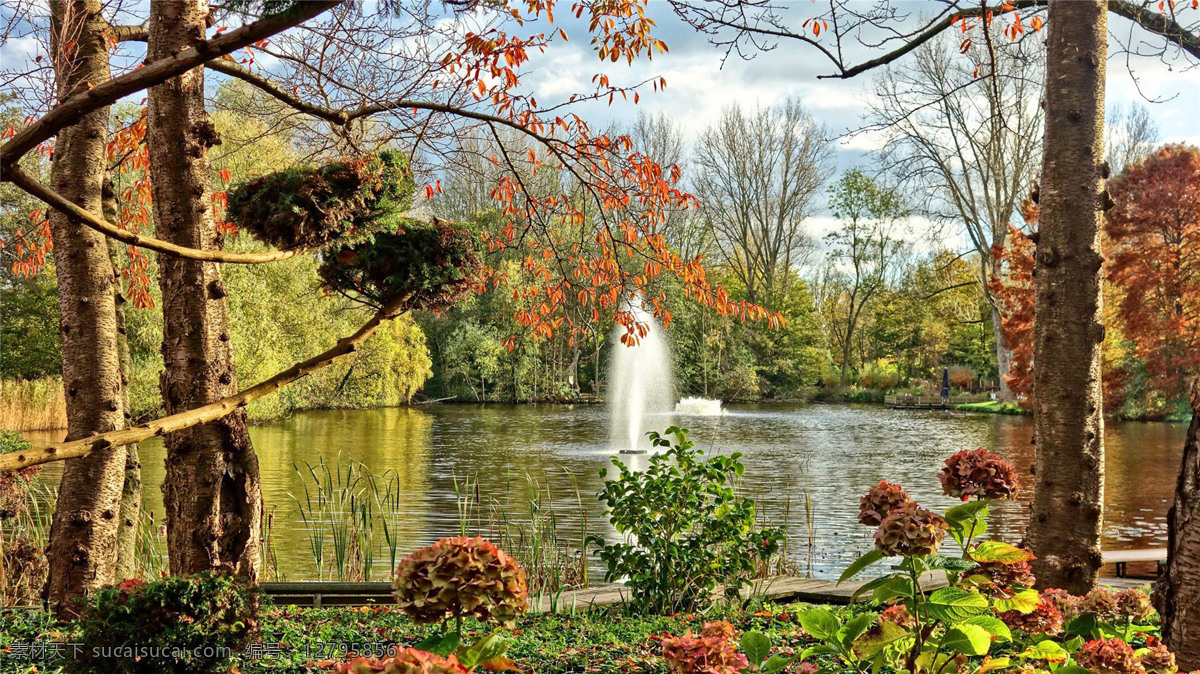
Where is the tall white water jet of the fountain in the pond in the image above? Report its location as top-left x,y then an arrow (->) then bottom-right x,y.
608,295 -> 676,453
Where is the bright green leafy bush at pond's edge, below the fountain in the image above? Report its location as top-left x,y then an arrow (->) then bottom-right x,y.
588,426 -> 784,613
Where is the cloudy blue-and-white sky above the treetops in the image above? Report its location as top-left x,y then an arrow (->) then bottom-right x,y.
513,0 -> 1200,241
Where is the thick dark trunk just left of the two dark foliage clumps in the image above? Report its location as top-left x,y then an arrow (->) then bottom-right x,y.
146,0 -> 263,579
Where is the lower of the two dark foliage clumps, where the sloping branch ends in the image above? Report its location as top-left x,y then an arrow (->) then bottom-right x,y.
319,218 -> 482,309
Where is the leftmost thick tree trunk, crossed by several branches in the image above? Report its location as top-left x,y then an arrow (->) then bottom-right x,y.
44,0 -> 125,616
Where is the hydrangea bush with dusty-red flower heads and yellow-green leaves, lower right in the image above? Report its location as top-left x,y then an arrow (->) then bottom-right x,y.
799,449 -> 1174,674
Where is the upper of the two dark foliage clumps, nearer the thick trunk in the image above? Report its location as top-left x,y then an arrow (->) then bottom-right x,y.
227,151 -> 416,249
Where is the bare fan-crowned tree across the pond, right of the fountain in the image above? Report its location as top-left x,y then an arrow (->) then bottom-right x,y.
695,100 -> 830,305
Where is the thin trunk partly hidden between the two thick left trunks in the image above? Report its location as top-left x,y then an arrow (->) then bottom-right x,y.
103,177 -> 142,580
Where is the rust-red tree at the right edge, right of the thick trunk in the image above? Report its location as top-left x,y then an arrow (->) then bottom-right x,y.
1104,145 -> 1200,399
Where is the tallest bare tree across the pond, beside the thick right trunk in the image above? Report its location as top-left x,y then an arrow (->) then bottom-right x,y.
870,25 -> 1043,399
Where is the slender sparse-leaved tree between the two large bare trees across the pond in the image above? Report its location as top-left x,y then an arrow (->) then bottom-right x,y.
822,169 -> 907,386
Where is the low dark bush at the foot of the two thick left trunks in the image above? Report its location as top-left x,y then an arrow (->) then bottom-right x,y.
70,572 -> 258,673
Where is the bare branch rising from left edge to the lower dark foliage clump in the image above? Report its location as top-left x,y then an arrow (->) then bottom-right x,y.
0,290 -> 412,473
